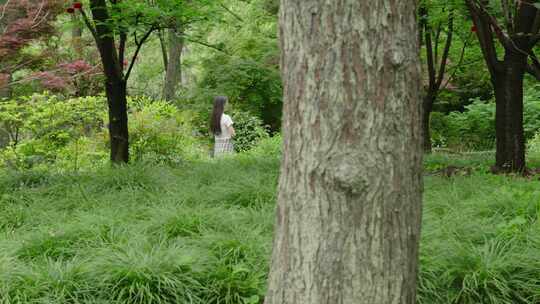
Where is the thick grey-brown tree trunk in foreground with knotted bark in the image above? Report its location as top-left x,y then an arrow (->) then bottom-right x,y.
265,0 -> 423,304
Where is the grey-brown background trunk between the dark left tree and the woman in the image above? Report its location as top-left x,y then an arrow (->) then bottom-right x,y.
163,28 -> 184,101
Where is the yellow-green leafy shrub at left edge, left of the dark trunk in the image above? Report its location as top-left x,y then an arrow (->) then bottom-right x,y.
0,93 -> 106,168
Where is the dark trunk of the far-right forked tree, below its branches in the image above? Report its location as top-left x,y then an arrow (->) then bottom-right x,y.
493,50 -> 527,172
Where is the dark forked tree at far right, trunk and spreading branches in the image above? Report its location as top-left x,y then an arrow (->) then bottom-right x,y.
465,0 -> 540,172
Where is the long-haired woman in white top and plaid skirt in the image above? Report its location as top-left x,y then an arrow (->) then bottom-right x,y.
210,96 -> 235,157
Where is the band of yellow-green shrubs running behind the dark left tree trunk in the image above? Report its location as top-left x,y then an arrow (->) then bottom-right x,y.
0,94 -> 204,171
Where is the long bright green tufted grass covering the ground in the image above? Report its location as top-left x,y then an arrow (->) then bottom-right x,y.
0,146 -> 540,304
